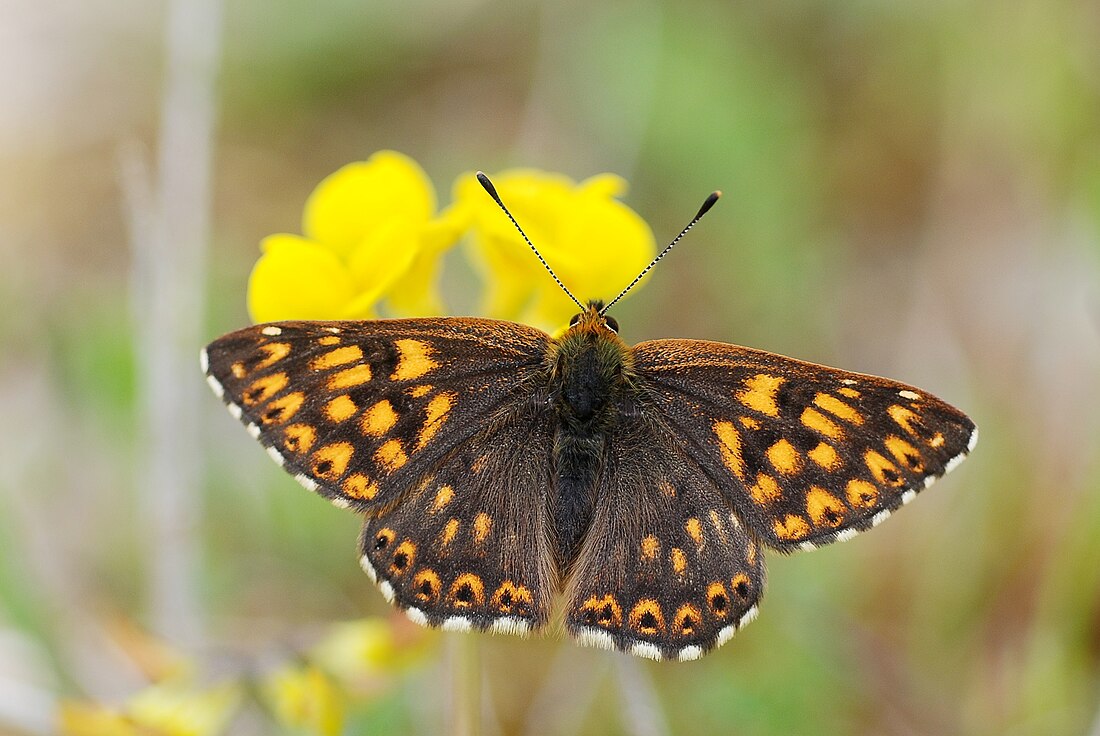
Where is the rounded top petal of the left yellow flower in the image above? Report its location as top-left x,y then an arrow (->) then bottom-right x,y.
303,151 -> 436,255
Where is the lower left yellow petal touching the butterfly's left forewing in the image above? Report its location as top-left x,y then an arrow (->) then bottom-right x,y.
249,234 -> 355,322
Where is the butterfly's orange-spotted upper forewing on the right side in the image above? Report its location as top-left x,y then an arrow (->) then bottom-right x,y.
634,340 -> 978,550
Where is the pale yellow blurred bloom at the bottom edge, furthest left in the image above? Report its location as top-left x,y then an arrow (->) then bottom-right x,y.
58,679 -> 240,736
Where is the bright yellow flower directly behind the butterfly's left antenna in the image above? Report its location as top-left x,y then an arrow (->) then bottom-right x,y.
454,169 -> 655,329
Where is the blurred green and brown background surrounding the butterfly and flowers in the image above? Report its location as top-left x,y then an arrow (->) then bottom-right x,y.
0,0 -> 1100,735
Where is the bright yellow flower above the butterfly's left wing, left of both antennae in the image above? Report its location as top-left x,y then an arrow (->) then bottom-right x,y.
249,151 -> 463,322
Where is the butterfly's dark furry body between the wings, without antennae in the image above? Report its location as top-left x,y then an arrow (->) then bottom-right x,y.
547,303 -> 634,568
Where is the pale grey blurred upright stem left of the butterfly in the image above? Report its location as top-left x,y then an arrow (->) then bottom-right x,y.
121,0 -> 222,646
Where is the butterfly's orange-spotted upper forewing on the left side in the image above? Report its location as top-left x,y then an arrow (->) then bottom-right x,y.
202,318 -> 549,510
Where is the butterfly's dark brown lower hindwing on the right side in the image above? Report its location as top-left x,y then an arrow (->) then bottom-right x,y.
565,409 -> 765,660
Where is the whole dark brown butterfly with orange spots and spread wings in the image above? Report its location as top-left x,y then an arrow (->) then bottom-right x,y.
201,175 -> 978,660
